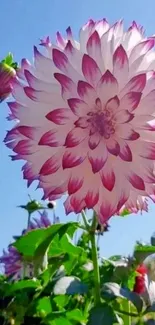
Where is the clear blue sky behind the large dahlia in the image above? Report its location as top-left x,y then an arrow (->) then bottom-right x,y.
0,0 -> 155,256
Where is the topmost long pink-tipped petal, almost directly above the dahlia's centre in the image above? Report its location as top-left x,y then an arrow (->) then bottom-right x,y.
87,31 -> 104,73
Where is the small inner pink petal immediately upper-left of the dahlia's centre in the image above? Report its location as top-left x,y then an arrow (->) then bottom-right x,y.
68,98 -> 90,117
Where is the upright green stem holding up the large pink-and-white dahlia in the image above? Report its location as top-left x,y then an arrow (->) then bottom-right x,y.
89,215 -> 101,306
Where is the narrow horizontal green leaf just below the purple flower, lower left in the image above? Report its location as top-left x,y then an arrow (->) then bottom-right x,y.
6,279 -> 41,296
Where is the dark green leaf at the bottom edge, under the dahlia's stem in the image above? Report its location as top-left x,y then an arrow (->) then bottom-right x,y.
88,305 -> 118,325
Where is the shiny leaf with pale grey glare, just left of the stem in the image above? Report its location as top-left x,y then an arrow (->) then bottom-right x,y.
53,276 -> 88,295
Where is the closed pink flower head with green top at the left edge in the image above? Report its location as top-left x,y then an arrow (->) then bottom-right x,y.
0,54 -> 17,103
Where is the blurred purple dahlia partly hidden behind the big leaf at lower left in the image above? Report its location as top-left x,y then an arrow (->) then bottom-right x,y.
0,211 -> 55,280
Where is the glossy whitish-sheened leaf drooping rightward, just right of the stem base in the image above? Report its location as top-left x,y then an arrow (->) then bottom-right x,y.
103,282 -> 143,312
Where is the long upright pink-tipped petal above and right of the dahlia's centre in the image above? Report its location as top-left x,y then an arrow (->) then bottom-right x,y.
113,45 -> 129,89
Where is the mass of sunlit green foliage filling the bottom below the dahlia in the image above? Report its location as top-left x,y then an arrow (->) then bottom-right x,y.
0,201 -> 155,325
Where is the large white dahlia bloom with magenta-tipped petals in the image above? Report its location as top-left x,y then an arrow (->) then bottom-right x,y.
5,19 -> 155,223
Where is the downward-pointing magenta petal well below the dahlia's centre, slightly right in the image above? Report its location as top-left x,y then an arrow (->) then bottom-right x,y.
100,162 -> 115,192
